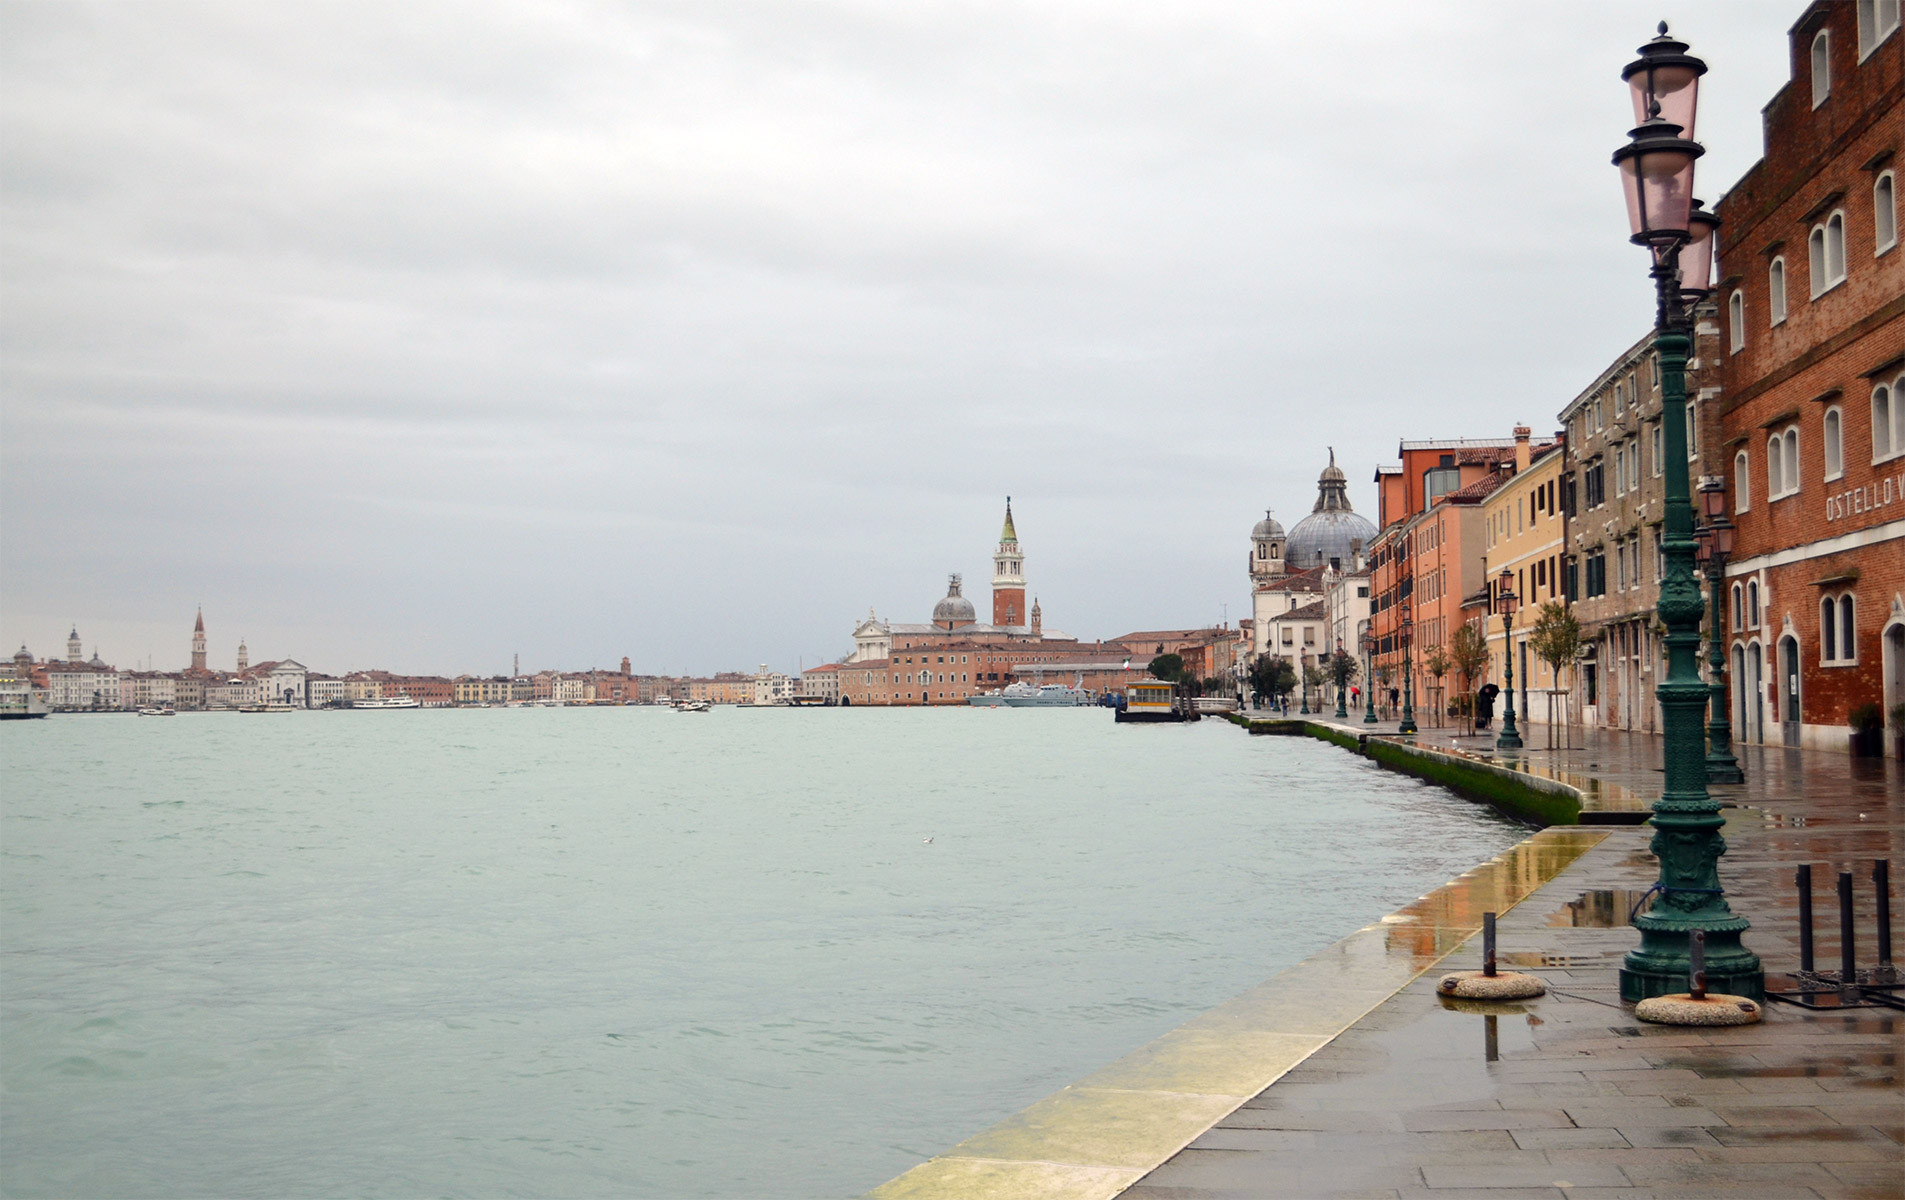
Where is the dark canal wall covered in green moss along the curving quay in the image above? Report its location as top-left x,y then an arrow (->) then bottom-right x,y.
1229,712 -> 1648,827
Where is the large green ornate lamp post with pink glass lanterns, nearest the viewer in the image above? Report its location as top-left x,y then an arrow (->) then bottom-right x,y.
1614,21 -> 1766,1000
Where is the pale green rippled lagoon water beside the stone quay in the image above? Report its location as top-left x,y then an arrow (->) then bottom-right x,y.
0,709 -> 1526,1196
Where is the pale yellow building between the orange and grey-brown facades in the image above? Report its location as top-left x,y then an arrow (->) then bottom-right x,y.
1482,425 -> 1570,724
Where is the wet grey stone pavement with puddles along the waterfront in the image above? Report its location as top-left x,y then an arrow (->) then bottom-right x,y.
1122,722 -> 1905,1200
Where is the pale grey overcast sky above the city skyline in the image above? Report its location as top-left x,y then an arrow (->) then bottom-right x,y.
0,0 -> 1804,672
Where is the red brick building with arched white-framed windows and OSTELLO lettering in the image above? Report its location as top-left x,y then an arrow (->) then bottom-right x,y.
1715,0 -> 1905,750
